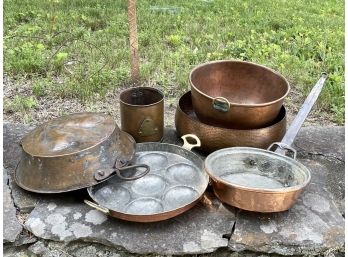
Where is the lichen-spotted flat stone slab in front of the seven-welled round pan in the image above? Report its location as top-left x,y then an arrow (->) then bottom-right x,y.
25,195 -> 235,255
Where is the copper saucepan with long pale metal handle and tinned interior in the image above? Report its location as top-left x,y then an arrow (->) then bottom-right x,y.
204,73 -> 327,212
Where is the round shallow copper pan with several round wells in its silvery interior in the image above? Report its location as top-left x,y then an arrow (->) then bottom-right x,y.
86,143 -> 209,222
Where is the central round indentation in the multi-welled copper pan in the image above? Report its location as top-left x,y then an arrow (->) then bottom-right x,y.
132,174 -> 166,196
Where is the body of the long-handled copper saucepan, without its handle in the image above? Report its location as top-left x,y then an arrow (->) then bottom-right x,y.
205,147 -> 311,212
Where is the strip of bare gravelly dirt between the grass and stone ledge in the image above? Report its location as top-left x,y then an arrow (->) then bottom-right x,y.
3,78 -> 336,126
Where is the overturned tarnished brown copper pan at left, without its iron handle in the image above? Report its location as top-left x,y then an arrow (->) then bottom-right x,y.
15,113 -> 135,193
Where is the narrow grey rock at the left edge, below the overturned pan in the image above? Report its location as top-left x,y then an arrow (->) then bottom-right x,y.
3,178 -> 22,243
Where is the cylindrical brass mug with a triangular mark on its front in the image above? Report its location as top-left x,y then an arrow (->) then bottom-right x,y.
120,87 -> 164,143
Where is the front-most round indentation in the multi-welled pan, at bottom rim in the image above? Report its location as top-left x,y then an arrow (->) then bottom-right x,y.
126,197 -> 163,215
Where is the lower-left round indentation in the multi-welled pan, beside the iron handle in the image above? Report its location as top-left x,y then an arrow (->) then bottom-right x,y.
94,185 -> 131,206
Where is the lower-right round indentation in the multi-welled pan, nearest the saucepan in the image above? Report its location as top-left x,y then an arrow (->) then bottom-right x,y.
163,186 -> 199,210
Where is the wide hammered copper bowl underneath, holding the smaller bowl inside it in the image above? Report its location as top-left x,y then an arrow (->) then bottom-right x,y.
175,92 -> 286,153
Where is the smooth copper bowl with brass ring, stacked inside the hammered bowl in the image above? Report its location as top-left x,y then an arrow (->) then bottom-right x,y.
189,60 -> 290,129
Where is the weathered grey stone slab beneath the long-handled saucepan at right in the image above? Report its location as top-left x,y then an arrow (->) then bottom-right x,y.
229,160 -> 344,255
